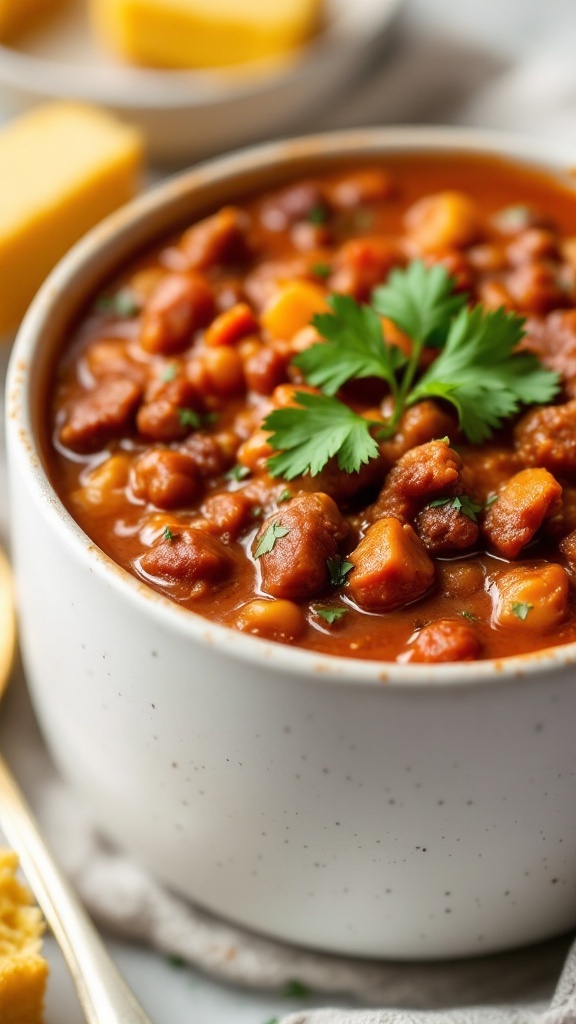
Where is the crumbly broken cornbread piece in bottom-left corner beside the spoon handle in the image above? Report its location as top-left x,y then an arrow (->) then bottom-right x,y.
0,850 -> 48,1024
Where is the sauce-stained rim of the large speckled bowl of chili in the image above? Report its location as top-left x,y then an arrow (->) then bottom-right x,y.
6,126 -> 576,689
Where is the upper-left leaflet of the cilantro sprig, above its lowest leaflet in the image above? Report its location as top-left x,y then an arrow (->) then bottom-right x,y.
293,295 -> 406,395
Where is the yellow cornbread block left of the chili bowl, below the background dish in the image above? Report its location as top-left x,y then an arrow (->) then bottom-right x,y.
0,103 -> 141,336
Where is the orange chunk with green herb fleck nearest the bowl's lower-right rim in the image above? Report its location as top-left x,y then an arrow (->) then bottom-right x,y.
490,562 -> 569,633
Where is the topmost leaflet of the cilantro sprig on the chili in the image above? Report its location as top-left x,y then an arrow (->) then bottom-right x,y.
372,260 -> 466,347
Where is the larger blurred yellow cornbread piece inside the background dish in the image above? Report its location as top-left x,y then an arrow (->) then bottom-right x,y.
91,0 -> 321,68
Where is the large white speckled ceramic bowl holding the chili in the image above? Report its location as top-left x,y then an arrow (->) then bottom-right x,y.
8,129 -> 576,958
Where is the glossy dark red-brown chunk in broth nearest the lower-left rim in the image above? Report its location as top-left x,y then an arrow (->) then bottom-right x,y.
139,527 -> 234,587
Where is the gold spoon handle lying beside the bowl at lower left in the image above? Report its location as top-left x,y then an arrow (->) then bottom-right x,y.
0,757 -> 152,1024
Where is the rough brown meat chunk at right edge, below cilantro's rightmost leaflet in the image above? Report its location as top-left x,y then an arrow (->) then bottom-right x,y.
515,399 -> 576,480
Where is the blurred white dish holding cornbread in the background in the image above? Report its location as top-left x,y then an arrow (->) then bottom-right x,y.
0,0 -> 402,164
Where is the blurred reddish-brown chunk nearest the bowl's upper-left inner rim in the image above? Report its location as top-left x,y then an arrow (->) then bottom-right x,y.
179,206 -> 250,270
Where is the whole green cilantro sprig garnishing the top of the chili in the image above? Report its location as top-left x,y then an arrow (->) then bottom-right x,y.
263,261 -> 560,477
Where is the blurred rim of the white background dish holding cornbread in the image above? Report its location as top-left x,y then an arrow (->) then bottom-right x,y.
0,0 -> 405,111
